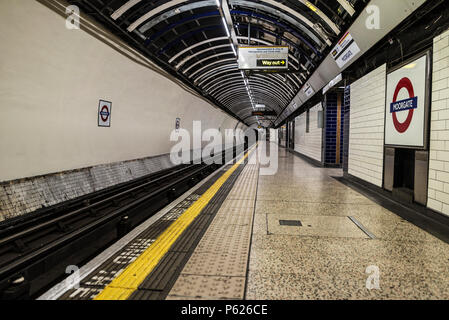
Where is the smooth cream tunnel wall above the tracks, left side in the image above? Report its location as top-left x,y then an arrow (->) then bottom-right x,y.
0,0 -> 245,181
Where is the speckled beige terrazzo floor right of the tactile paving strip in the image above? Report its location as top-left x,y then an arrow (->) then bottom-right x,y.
246,148 -> 449,300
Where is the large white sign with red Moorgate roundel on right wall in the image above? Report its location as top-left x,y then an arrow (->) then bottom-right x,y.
385,54 -> 429,148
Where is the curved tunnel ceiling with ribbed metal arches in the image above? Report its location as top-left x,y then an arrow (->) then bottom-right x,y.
68,0 -> 368,127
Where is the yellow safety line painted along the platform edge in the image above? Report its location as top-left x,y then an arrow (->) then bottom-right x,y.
94,147 -> 254,300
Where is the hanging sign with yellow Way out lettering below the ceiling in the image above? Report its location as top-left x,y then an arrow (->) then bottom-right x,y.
239,46 -> 288,71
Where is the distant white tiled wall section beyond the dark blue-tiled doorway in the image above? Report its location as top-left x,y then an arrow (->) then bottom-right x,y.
295,103 -> 323,162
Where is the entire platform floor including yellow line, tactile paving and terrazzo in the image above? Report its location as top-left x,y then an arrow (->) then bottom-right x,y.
43,145 -> 449,300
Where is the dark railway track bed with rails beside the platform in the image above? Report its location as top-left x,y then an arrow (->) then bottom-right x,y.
0,148 -> 245,300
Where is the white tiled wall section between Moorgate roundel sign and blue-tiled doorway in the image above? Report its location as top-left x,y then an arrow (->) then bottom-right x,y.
348,65 -> 386,187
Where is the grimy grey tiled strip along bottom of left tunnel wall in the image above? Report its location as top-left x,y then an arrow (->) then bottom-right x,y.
0,155 -> 173,221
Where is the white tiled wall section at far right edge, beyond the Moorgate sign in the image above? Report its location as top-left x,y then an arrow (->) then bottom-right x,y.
427,30 -> 449,215
